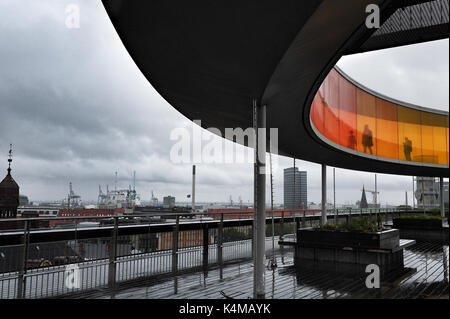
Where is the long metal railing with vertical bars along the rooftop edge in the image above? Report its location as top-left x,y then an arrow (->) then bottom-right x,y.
0,209 -> 440,299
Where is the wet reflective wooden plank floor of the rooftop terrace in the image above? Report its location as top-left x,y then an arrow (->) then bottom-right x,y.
68,242 -> 449,299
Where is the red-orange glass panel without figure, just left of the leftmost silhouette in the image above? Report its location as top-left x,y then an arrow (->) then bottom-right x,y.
323,69 -> 339,143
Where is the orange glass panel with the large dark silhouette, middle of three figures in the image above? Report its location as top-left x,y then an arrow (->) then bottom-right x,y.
356,88 -> 377,155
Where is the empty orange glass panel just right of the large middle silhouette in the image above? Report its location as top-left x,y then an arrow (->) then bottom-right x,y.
375,98 -> 398,159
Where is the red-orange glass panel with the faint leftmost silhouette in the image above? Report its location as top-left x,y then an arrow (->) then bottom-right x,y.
339,76 -> 357,150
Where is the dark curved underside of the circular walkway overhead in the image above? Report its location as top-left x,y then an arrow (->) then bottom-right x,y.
103,0 -> 448,176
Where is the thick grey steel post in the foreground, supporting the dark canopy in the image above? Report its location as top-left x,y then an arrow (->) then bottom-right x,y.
253,100 -> 266,299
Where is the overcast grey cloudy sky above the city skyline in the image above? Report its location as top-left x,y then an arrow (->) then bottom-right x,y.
0,0 -> 449,204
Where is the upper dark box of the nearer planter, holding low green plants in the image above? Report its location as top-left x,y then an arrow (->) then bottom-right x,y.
297,228 -> 400,250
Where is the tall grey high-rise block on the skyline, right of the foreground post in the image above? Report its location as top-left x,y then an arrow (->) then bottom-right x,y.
284,167 -> 308,209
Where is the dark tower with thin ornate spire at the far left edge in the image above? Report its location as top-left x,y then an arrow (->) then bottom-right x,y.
0,144 -> 19,218
